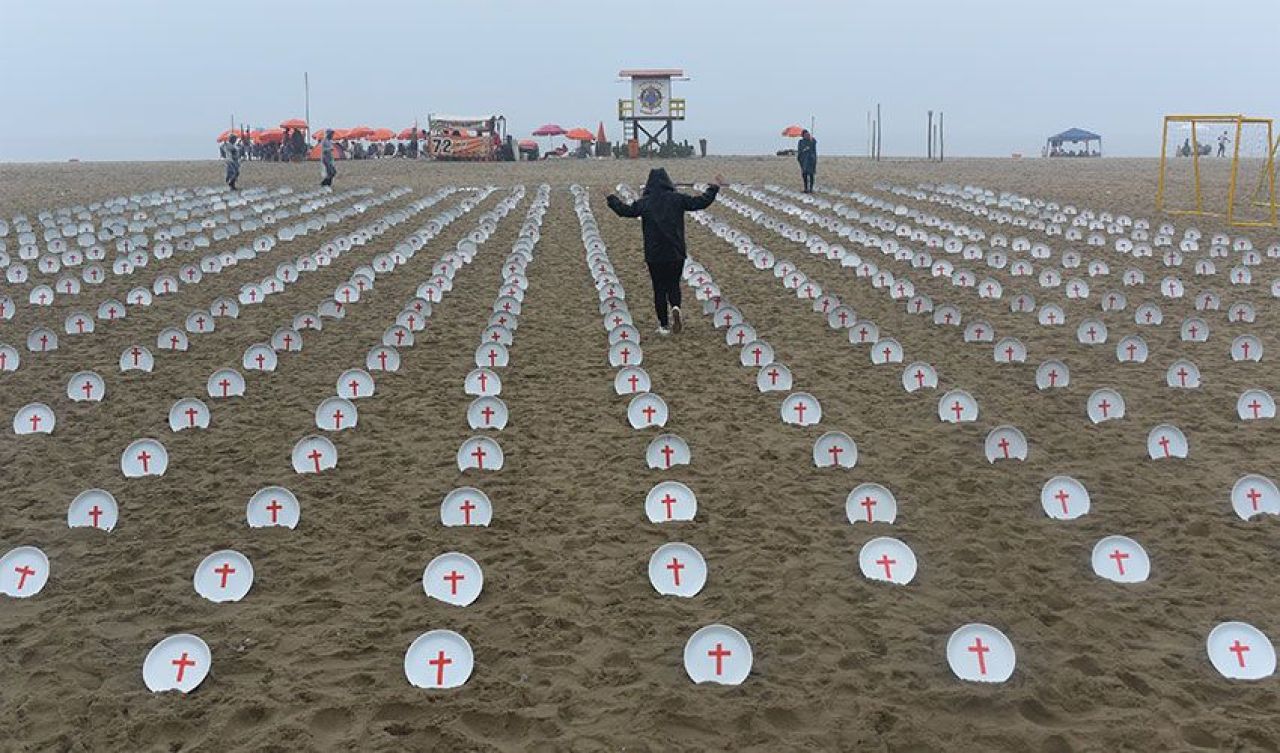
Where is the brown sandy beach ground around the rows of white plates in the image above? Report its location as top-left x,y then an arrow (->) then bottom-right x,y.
0,158 -> 1280,753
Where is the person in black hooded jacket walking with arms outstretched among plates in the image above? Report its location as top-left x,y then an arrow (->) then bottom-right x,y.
607,168 -> 724,334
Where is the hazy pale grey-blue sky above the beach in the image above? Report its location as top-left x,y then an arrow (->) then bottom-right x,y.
0,0 -> 1280,161
